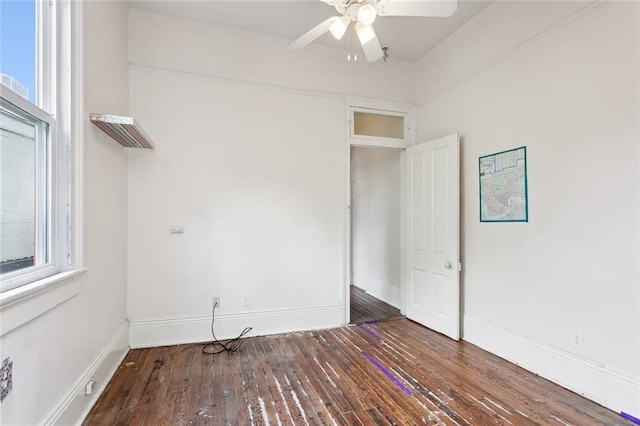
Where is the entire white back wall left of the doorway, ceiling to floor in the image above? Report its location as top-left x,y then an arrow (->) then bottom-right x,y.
128,10 -> 413,347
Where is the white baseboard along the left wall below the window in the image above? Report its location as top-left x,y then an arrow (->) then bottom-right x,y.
39,322 -> 129,425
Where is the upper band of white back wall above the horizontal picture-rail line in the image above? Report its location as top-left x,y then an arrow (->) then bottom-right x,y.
130,9 -> 414,103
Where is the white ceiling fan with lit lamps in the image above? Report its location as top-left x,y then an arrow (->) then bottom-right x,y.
287,0 -> 458,62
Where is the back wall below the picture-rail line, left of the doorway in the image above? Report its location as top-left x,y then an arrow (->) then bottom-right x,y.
128,67 -> 346,346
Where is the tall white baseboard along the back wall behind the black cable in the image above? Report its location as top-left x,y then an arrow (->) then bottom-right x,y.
129,305 -> 344,348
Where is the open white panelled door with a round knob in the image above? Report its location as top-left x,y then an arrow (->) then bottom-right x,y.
403,135 -> 460,340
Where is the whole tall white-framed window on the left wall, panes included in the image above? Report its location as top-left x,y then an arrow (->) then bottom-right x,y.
0,0 -> 70,291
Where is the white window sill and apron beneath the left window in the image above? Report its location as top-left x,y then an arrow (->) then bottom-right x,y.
0,268 -> 87,336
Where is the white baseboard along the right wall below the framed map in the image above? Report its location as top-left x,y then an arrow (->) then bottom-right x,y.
464,315 -> 640,417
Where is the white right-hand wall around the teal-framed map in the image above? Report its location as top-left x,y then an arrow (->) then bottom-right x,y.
416,2 -> 640,416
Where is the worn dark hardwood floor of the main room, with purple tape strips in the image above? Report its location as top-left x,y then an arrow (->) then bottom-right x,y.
84,319 -> 630,425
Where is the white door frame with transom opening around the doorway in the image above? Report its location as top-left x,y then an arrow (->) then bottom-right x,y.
343,98 -> 415,325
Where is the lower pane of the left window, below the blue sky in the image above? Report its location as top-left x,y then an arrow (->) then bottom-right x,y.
0,102 -> 48,273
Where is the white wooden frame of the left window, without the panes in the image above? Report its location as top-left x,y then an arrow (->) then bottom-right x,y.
0,1 -> 72,294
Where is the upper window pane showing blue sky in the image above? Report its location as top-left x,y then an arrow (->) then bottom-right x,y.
0,0 -> 36,103
